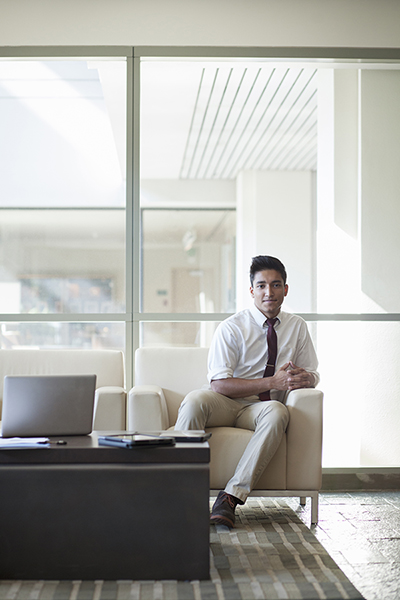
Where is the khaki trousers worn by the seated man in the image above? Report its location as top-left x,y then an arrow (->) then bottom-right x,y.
175,390 -> 289,502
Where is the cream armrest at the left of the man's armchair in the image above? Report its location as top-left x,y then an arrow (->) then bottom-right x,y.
128,385 -> 169,431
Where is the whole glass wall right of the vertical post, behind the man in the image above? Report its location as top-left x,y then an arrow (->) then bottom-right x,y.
140,59 -> 400,467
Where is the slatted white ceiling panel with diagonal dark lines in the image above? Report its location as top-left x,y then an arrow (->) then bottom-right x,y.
180,65 -> 317,179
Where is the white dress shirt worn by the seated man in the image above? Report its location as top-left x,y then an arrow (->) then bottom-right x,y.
208,305 -> 319,401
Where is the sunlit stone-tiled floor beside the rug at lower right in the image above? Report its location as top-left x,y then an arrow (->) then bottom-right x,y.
288,491 -> 400,600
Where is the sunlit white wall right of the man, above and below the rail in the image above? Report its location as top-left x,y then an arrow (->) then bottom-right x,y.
317,70 -> 400,467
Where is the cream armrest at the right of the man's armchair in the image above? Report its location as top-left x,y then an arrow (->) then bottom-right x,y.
286,388 -> 323,490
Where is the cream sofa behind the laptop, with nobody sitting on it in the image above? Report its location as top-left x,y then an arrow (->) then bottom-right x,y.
0,349 -> 126,430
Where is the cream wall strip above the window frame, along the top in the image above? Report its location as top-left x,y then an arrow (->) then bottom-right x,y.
0,0 -> 400,47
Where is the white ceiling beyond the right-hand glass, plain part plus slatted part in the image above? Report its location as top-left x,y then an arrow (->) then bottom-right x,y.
141,62 -> 317,179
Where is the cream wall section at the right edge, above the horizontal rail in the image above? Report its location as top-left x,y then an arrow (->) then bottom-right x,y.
360,71 -> 400,312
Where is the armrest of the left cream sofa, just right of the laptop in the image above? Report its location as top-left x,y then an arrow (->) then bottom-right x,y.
93,386 -> 126,430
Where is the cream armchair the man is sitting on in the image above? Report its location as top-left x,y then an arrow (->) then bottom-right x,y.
127,348 -> 323,523
